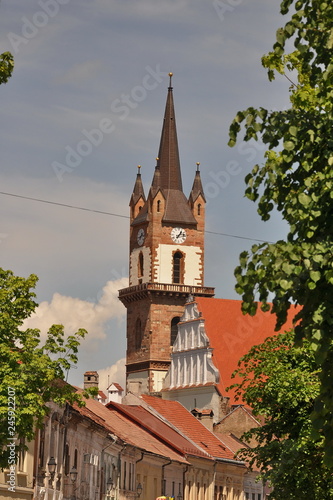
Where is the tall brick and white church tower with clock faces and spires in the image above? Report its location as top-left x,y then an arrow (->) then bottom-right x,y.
119,73 -> 214,394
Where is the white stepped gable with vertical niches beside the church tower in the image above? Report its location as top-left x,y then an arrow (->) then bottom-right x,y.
164,297 -> 219,389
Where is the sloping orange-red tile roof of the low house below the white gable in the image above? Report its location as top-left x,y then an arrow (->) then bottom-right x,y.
141,395 -> 239,460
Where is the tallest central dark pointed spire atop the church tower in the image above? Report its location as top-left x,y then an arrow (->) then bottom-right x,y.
157,73 -> 183,191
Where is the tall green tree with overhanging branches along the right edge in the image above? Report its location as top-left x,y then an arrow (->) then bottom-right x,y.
229,0 -> 333,465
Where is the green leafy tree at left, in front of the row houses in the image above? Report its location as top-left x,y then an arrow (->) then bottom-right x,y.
0,268 -> 91,468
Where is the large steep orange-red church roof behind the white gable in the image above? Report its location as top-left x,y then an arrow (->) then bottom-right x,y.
195,297 -> 296,404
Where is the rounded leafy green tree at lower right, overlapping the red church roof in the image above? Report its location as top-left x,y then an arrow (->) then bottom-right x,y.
231,331 -> 333,500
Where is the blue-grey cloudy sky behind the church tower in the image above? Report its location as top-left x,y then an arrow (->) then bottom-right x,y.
0,0 -> 289,385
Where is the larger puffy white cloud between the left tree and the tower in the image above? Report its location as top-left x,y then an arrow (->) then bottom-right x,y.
23,278 -> 128,348
